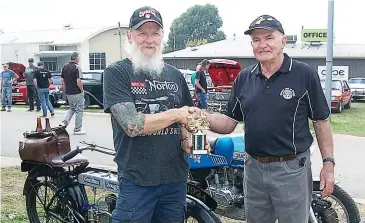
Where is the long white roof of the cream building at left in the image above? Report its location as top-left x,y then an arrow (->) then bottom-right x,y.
0,26 -> 128,45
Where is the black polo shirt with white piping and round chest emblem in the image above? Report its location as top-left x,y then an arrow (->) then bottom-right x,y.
225,54 -> 330,156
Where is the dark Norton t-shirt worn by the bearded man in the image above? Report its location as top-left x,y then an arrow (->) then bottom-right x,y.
104,59 -> 193,186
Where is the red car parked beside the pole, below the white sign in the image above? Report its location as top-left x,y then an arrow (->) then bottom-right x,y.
321,80 -> 352,113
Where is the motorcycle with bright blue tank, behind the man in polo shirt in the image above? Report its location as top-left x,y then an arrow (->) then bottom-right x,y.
189,134 -> 360,223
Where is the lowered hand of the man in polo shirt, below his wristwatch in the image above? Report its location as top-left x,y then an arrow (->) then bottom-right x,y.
319,162 -> 335,197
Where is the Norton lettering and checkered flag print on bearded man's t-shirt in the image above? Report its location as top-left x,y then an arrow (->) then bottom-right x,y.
131,80 -> 179,94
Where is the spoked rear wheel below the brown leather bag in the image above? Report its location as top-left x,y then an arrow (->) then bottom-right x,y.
25,180 -> 77,223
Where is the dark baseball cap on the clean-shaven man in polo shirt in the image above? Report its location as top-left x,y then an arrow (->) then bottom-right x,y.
245,15 -> 284,35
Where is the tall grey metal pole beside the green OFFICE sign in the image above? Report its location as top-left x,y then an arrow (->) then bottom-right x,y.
325,0 -> 334,117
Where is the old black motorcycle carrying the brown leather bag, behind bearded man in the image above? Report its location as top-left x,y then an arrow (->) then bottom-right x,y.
21,142 -> 221,223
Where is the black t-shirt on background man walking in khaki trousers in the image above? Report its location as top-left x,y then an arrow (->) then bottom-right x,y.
61,61 -> 82,95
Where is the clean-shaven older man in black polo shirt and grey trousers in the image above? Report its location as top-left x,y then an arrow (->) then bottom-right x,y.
191,15 -> 334,223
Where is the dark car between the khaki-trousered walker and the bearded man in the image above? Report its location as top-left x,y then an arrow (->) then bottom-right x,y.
81,70 -> 104,108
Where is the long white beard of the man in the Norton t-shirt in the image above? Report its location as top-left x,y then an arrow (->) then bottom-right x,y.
124,38 -> 164,79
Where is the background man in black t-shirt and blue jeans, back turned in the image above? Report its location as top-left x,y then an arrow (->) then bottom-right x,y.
34,61 -> 54,117
